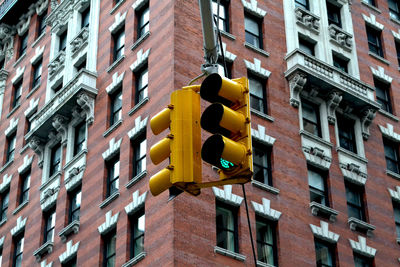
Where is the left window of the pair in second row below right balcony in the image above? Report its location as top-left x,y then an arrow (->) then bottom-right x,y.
308,168 -> 329,207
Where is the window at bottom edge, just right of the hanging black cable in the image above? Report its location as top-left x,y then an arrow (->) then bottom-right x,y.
256,216 -> 277,266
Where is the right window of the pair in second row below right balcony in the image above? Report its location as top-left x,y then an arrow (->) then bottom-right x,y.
345,182 -> 366,221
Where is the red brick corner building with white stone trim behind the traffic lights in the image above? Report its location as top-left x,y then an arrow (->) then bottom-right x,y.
0,0 -> 400,267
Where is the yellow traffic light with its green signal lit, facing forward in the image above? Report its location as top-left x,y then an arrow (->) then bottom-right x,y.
200,73 -> 253,181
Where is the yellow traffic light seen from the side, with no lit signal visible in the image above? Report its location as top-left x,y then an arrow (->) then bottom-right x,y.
149,86 -> 201,196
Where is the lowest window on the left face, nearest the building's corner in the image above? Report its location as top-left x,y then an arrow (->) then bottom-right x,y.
130,208 -> 145,259
